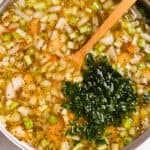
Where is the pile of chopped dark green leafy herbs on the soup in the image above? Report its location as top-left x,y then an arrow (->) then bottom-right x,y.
63,54 -> 137,143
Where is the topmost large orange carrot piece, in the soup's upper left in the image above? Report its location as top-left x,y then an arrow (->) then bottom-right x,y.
29,18 -> 40,35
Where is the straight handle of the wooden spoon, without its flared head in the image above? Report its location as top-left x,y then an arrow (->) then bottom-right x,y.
80,0 -> 136,57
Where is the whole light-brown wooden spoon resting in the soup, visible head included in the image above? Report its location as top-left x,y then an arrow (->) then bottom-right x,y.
67,0 -> 136,70
